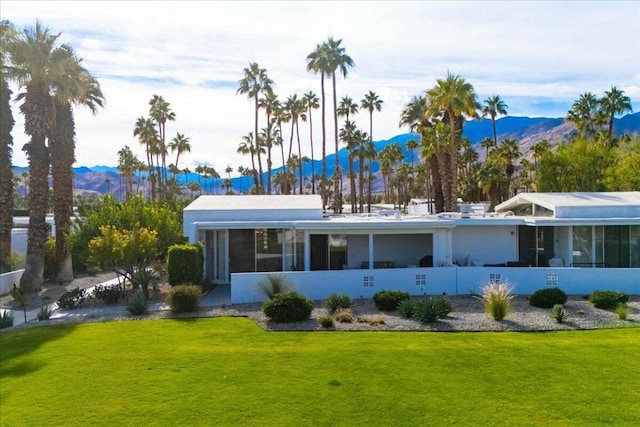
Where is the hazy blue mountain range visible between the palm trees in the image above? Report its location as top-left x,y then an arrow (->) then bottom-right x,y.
13,113 -> 640,195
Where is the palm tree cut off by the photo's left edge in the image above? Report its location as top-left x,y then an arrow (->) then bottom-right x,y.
0,21 -> 16,274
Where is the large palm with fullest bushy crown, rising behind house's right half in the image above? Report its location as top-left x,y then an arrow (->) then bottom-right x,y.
427,73 -> 480,211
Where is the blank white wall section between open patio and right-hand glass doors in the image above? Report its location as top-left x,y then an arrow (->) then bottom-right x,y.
453,225 -> 518,264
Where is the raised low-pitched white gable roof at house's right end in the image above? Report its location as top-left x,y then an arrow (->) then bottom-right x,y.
495,191 -> 640,219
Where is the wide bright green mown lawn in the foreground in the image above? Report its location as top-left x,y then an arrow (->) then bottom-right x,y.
0,318 -> 640,426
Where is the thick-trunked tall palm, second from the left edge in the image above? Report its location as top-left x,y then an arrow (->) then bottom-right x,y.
7,22 -> 76,290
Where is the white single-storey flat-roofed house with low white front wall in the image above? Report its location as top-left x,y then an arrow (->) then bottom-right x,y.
184,192 -> 640,303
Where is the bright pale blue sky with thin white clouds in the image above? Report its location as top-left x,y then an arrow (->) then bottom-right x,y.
5,0 -> 640,175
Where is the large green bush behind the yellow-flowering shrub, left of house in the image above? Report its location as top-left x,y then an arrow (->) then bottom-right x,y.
68,195 -> 184,271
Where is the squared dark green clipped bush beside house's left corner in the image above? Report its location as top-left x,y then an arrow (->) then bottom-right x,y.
167,243 -> 204,286
